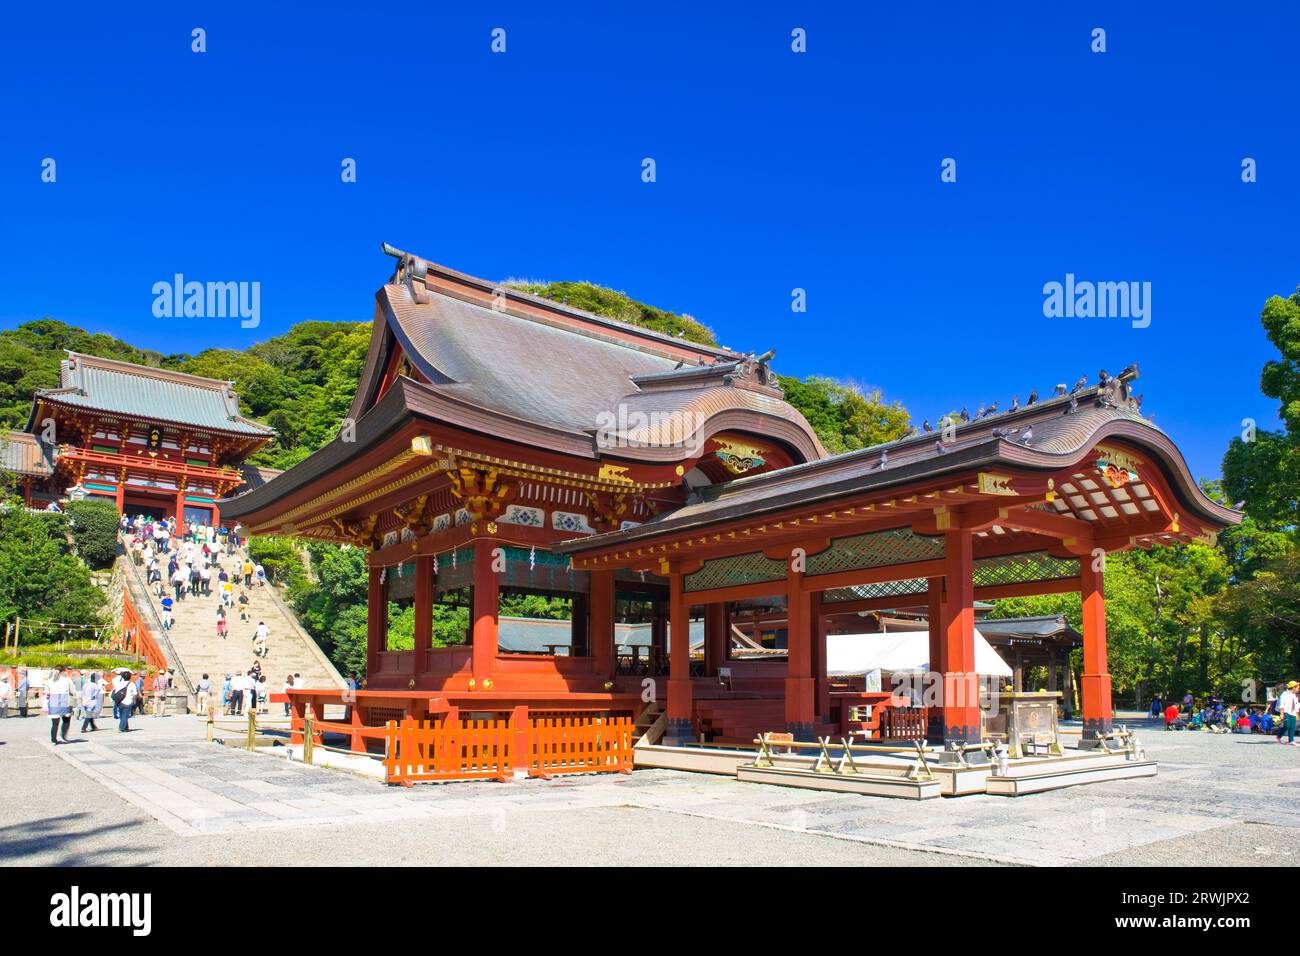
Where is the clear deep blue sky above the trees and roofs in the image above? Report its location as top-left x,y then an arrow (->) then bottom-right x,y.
0,1 -> 1300,475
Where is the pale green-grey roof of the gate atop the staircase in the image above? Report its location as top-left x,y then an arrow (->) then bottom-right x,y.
36,352 -> 274,437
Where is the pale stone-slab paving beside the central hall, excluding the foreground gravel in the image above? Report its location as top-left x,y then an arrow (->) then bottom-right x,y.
10,719 -> 1300,865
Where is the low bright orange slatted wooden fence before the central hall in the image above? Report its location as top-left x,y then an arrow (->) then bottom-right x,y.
384,717 -> 633,786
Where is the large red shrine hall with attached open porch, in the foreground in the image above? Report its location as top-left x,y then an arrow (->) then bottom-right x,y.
220,247 -> 1238,764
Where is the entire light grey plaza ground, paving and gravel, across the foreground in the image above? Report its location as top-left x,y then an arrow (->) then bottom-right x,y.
0,715 -> 1300,866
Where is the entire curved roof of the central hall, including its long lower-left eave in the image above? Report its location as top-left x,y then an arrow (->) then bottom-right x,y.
213,247 -> 826,516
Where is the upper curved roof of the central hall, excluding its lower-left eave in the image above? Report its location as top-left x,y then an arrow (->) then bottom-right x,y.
351,250 -> 826,460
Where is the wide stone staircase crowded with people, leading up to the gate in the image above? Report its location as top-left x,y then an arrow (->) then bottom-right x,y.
118,541 -> 346,707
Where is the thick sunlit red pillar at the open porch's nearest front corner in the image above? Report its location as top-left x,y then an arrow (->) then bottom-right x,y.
943,528 -> 982,747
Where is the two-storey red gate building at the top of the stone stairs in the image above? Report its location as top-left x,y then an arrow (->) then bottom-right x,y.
0,352 -> 278,524
